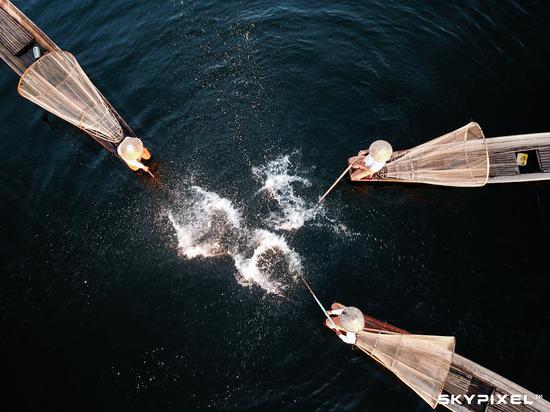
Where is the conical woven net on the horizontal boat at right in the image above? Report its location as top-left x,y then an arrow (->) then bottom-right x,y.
379,123 -> 489,187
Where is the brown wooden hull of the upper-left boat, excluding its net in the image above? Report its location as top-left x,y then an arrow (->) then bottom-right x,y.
0,0 -> 144,162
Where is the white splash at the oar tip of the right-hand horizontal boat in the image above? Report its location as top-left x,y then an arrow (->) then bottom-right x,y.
252,155 -> 320,230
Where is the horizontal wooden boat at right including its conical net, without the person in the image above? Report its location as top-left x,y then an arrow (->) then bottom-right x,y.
348,123 -> 550,187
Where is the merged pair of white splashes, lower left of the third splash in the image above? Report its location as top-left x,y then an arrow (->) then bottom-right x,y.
168,186 -> 302,295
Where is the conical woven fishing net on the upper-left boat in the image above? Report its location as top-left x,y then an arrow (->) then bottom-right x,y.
19,51 -> 123,143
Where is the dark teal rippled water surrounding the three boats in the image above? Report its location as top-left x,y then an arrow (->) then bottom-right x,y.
0,0 -> 550,411
